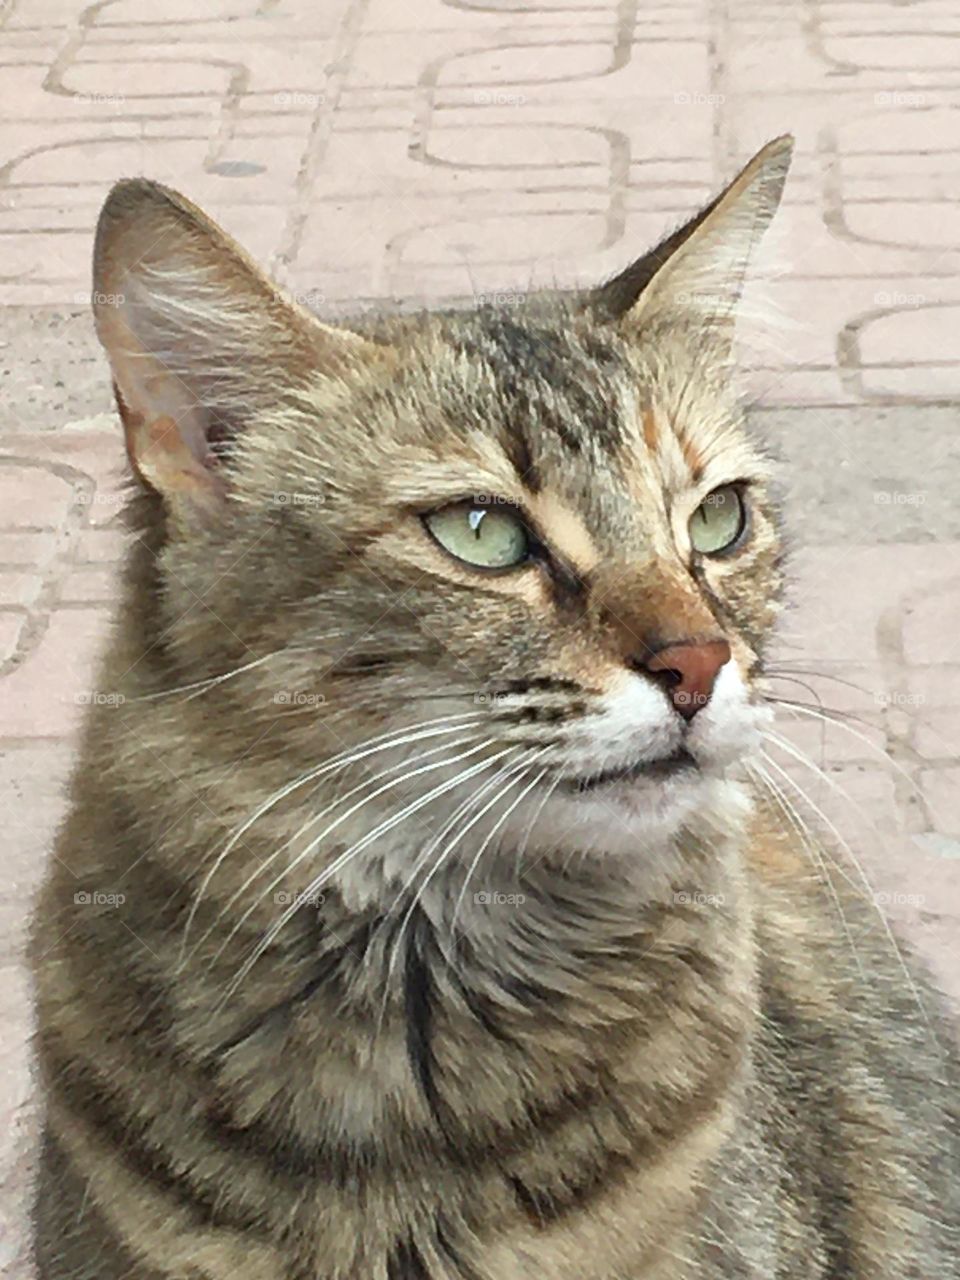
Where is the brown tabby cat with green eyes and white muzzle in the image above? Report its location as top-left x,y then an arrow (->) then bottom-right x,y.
32,138 -> 960,1280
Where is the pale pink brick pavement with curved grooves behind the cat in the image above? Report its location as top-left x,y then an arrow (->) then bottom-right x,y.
0,0 -> 960,1277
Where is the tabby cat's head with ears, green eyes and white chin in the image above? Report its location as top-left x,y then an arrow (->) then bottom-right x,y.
95,138 -> 791,880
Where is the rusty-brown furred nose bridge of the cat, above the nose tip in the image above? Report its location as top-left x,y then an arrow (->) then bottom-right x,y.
590,561 -> 719,662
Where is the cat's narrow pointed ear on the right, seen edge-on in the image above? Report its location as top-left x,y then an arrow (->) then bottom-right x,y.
589,134 -> 794,344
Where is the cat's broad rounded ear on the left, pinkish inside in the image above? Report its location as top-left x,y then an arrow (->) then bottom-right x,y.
93,179 -> 381,506
